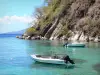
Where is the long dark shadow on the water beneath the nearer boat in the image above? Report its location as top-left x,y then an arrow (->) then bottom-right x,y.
31,62 -> 76,69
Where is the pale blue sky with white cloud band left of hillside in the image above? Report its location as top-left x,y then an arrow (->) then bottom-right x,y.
0,0 -> 44,33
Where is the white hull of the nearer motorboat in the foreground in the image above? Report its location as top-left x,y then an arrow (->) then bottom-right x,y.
31,55 -> 65,64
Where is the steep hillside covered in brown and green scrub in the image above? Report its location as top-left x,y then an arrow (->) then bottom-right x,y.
24,0 -> 100,41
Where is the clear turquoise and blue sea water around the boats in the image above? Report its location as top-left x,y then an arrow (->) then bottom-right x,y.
0,37 -> 100,75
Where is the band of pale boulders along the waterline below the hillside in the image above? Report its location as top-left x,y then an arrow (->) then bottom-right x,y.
16,32 -> 100,42
